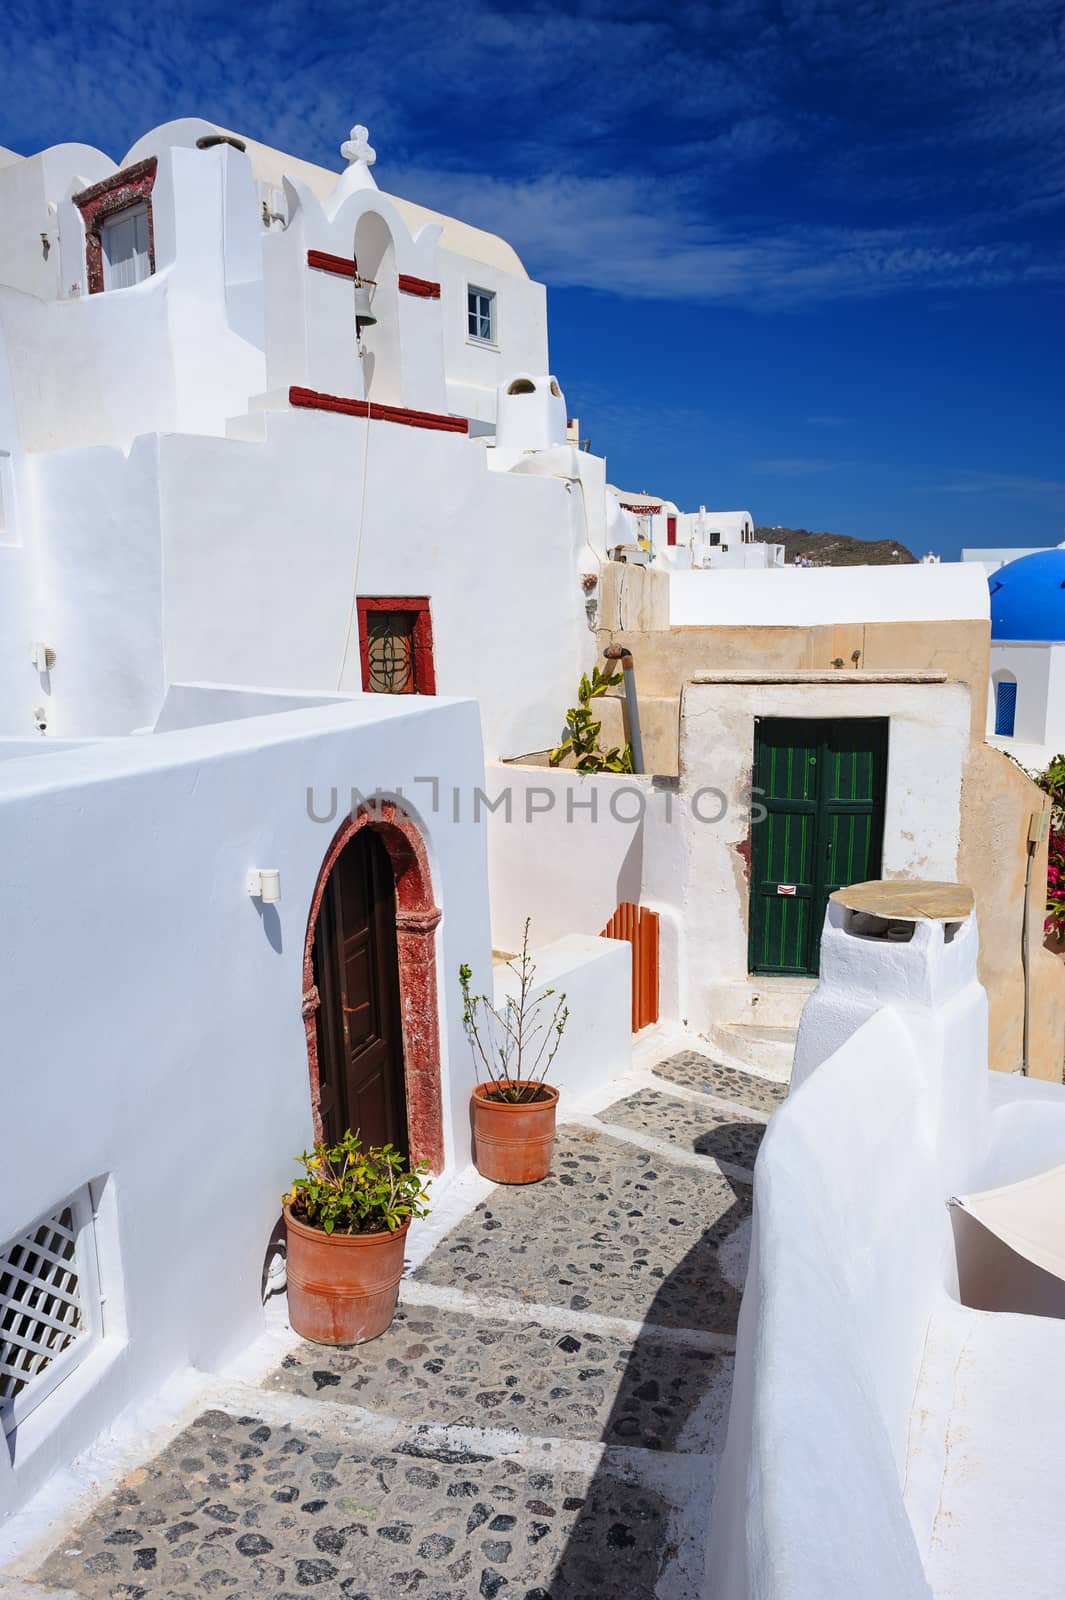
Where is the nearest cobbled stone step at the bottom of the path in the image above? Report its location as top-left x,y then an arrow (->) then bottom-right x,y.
30,1400 -> 687,1600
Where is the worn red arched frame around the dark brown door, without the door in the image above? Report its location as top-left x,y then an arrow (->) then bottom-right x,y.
302,802 -> 445,1173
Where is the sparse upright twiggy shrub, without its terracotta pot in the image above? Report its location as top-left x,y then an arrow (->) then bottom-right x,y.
459,917 -> 569,1106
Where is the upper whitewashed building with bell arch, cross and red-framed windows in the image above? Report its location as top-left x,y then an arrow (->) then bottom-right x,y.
0,120 -> 617,754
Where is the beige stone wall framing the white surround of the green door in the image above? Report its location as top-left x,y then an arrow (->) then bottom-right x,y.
600,565 -> 1065,1082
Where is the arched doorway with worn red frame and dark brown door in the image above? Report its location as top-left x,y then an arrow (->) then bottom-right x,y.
304,803 -> 445,1173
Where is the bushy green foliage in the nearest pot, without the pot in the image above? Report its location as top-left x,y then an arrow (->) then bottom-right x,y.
281,1128 -> 429,1234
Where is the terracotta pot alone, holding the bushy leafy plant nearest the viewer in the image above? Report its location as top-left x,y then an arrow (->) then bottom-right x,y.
285,1206 -> 411,1344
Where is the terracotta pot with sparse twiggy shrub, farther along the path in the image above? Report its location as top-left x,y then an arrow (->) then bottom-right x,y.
459,918 -> 569,1184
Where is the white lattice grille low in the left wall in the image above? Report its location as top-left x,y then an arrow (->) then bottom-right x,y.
0,1190 -> 98,1430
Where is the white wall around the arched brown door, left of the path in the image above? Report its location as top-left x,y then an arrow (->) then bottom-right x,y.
0,698 -> 493,1512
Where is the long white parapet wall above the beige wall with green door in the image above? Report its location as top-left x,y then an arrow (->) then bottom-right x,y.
670,562 -> 990,627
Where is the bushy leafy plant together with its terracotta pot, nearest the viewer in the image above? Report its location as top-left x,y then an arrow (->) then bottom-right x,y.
281,1130 -> 429,1344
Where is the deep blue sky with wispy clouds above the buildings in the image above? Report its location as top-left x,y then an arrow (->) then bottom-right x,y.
0,0 -> 1065,557
